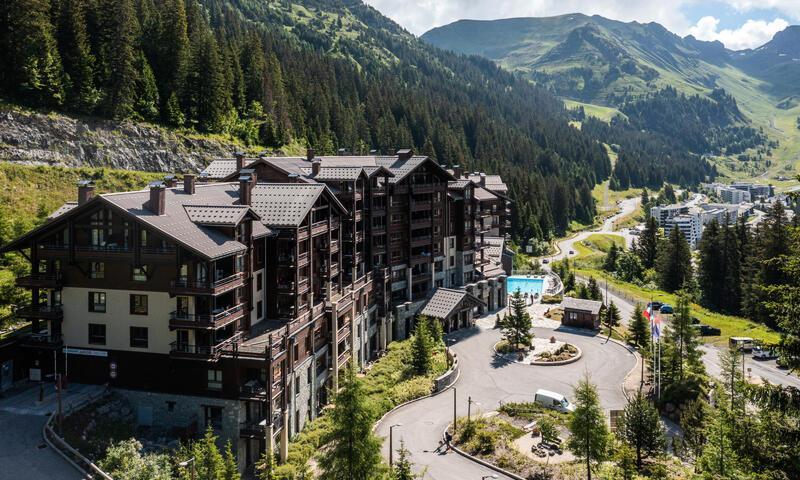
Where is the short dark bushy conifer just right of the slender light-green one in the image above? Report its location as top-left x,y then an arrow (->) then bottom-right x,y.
617,392 -> 666,471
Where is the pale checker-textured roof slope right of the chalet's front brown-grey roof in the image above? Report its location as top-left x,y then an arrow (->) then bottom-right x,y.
251,183 -> 325,227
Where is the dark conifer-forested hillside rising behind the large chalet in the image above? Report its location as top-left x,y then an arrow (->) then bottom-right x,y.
0,0 -> 611,242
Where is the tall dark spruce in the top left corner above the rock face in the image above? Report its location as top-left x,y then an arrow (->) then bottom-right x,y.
0,0 -> 64,107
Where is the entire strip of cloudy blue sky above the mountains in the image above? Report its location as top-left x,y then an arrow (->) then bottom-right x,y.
365,0 -> 800,50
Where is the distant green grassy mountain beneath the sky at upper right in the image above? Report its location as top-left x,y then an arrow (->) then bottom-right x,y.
422,14 -> 800,182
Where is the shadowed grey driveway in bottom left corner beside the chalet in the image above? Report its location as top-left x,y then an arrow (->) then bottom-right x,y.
0,383 -> 98,480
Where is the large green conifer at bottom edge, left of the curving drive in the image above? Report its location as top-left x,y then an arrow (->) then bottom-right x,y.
319,362 -> 381,480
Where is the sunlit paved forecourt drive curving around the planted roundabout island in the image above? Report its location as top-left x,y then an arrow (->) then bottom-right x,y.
377,315 -> 636,480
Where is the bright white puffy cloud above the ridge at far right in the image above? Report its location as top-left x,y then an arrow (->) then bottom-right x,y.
689,16 -> 789,50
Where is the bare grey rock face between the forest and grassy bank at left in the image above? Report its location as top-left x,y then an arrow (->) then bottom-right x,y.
0,109 -> 237,172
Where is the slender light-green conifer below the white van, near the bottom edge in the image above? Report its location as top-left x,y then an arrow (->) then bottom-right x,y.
567,376 -> 609,480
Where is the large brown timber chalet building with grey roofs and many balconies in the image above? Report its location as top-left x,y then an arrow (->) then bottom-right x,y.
2,150 -> 511,467
